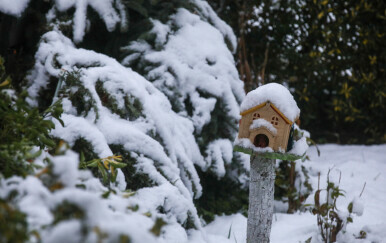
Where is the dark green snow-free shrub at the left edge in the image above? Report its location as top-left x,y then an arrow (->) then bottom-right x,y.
0,57 -> 63,178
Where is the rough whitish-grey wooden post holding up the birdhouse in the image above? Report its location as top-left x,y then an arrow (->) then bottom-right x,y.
247,156 -> 275,243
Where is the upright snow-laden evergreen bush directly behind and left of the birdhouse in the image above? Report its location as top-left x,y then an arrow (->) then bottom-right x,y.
122,0 -> 249,220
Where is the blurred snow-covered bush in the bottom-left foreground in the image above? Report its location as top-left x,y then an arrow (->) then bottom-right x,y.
0,148 -> 178,242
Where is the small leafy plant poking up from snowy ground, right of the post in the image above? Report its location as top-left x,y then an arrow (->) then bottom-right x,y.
311,170 -> 363,243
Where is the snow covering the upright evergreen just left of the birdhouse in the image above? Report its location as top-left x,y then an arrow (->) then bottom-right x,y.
122,5 -> 245,180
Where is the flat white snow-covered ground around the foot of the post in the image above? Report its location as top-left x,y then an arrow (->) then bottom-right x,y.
205,144 -> 386,243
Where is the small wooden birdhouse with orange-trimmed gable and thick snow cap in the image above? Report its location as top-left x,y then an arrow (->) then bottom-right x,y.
236,83 -> 300,153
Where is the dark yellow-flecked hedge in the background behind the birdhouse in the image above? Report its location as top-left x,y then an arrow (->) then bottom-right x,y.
209,0 -> 386,144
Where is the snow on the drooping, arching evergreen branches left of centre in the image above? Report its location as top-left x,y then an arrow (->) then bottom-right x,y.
28,31 -> 207,237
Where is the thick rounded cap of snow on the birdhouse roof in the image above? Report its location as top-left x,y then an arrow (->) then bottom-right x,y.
240,83 -> 300,122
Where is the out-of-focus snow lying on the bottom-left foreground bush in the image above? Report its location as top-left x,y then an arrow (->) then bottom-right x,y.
0,151 -> 170,243
